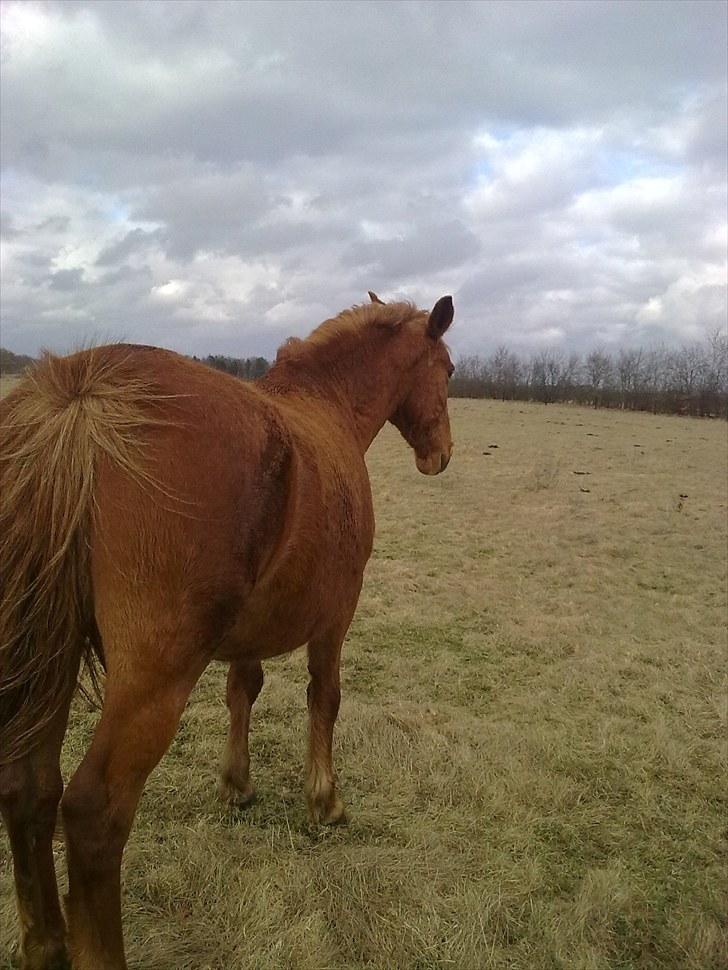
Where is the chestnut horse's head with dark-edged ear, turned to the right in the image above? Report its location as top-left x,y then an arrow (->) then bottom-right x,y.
370,293 -> 455,475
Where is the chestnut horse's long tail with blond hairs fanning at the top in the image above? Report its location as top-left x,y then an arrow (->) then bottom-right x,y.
0,346 -> 164,765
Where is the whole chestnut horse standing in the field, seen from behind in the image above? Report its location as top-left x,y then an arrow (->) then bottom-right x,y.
0,294 -> 453,970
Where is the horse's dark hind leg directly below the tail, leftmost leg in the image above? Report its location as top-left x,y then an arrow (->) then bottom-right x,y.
0,676 -> 73,970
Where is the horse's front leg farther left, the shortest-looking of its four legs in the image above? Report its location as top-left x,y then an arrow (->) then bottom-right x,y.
220,660 -> 263,808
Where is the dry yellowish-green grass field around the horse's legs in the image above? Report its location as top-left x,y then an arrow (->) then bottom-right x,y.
0,401 -> 728,970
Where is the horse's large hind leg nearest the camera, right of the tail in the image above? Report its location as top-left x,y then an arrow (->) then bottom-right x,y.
62,651 -> 204,970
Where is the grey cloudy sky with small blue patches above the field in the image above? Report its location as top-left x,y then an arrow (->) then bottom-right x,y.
0,0 -> 728,356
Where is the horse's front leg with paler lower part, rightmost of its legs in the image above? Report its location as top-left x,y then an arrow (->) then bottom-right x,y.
305,633 -> 345,825
